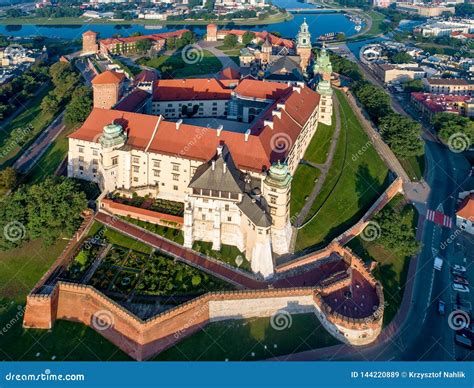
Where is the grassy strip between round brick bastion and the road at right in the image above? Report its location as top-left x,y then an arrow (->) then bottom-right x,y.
348,195 -> 418,326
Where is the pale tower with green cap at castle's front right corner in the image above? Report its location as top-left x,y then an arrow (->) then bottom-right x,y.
263,163 -> 291,255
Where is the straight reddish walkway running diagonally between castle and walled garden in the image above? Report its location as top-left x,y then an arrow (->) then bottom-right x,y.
95,212 -> 267,289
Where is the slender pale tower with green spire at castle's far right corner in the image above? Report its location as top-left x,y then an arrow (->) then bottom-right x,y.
313,46 -> 333,125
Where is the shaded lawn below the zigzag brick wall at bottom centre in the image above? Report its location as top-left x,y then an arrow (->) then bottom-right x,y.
155,313 -> 340,361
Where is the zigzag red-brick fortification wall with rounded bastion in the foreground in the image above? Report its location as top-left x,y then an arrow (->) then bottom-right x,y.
23,253 -> 383,360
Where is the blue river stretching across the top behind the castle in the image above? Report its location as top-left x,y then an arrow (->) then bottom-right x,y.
0,0 -> 356,41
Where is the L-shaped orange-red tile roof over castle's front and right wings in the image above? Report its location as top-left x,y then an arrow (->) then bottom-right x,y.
69,80 -> 320,171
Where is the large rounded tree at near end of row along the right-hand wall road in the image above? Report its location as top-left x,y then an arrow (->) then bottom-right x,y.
379,113 -> 423,158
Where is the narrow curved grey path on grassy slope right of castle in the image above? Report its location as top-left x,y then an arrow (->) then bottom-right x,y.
295,95 -> 341,228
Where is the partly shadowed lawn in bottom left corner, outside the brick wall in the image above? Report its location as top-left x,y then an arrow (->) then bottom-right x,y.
0,236 -> 129,361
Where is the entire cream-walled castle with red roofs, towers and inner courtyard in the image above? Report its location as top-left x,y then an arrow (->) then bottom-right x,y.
68,25 -> 332,277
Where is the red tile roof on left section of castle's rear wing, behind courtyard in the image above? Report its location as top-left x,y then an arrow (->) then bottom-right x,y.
153,78 -> 232,101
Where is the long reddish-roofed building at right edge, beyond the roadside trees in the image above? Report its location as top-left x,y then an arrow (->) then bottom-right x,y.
411,92 -> 474,119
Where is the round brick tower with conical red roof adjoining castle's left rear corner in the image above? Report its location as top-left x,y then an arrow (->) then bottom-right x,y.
92,70 -> 125,109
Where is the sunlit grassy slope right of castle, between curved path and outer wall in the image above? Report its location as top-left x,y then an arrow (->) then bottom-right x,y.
296,91 -> 388,251
